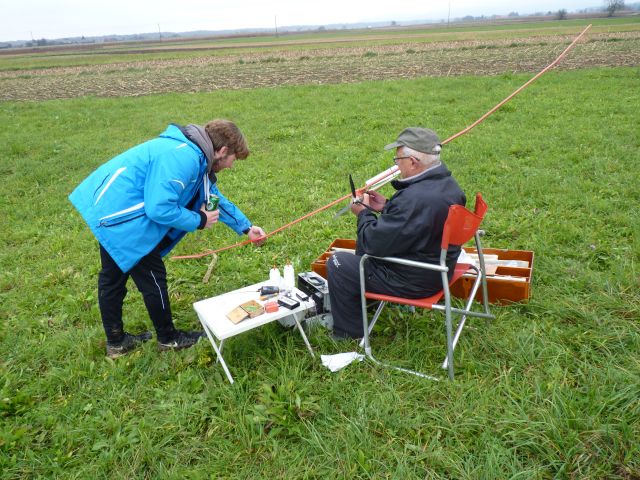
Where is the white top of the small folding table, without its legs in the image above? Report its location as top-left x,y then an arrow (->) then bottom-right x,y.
193,281 -> 315,340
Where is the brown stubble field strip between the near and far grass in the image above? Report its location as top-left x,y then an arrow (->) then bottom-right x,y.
0,31 -> 640,100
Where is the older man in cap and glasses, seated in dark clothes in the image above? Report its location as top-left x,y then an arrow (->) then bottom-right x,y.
327,127 -> 466,339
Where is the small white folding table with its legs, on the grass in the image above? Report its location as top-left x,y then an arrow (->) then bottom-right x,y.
193,281 -> 315,383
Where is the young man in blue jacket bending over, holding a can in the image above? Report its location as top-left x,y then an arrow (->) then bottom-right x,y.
69,120 -> 265,358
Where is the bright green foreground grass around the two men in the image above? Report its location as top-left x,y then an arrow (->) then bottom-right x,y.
0,68 -> 640,479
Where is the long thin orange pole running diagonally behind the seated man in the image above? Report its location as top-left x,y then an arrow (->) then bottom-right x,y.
171,24 -> 591,260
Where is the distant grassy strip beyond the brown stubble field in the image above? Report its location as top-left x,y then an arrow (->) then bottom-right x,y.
0,17 -> 640,71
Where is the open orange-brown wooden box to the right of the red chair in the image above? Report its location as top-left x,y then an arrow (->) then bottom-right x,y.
451,247 -> 534,304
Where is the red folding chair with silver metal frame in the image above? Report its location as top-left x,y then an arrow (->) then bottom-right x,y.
360,193 -> 495,380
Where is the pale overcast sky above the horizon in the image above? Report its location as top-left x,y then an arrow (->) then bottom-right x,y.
0,0 -> 604,41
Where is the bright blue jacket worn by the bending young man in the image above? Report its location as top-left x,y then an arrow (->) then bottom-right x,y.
69,125 -> 251,272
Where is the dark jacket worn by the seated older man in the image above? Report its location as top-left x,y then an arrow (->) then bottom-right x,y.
357,163 -> 466,297
